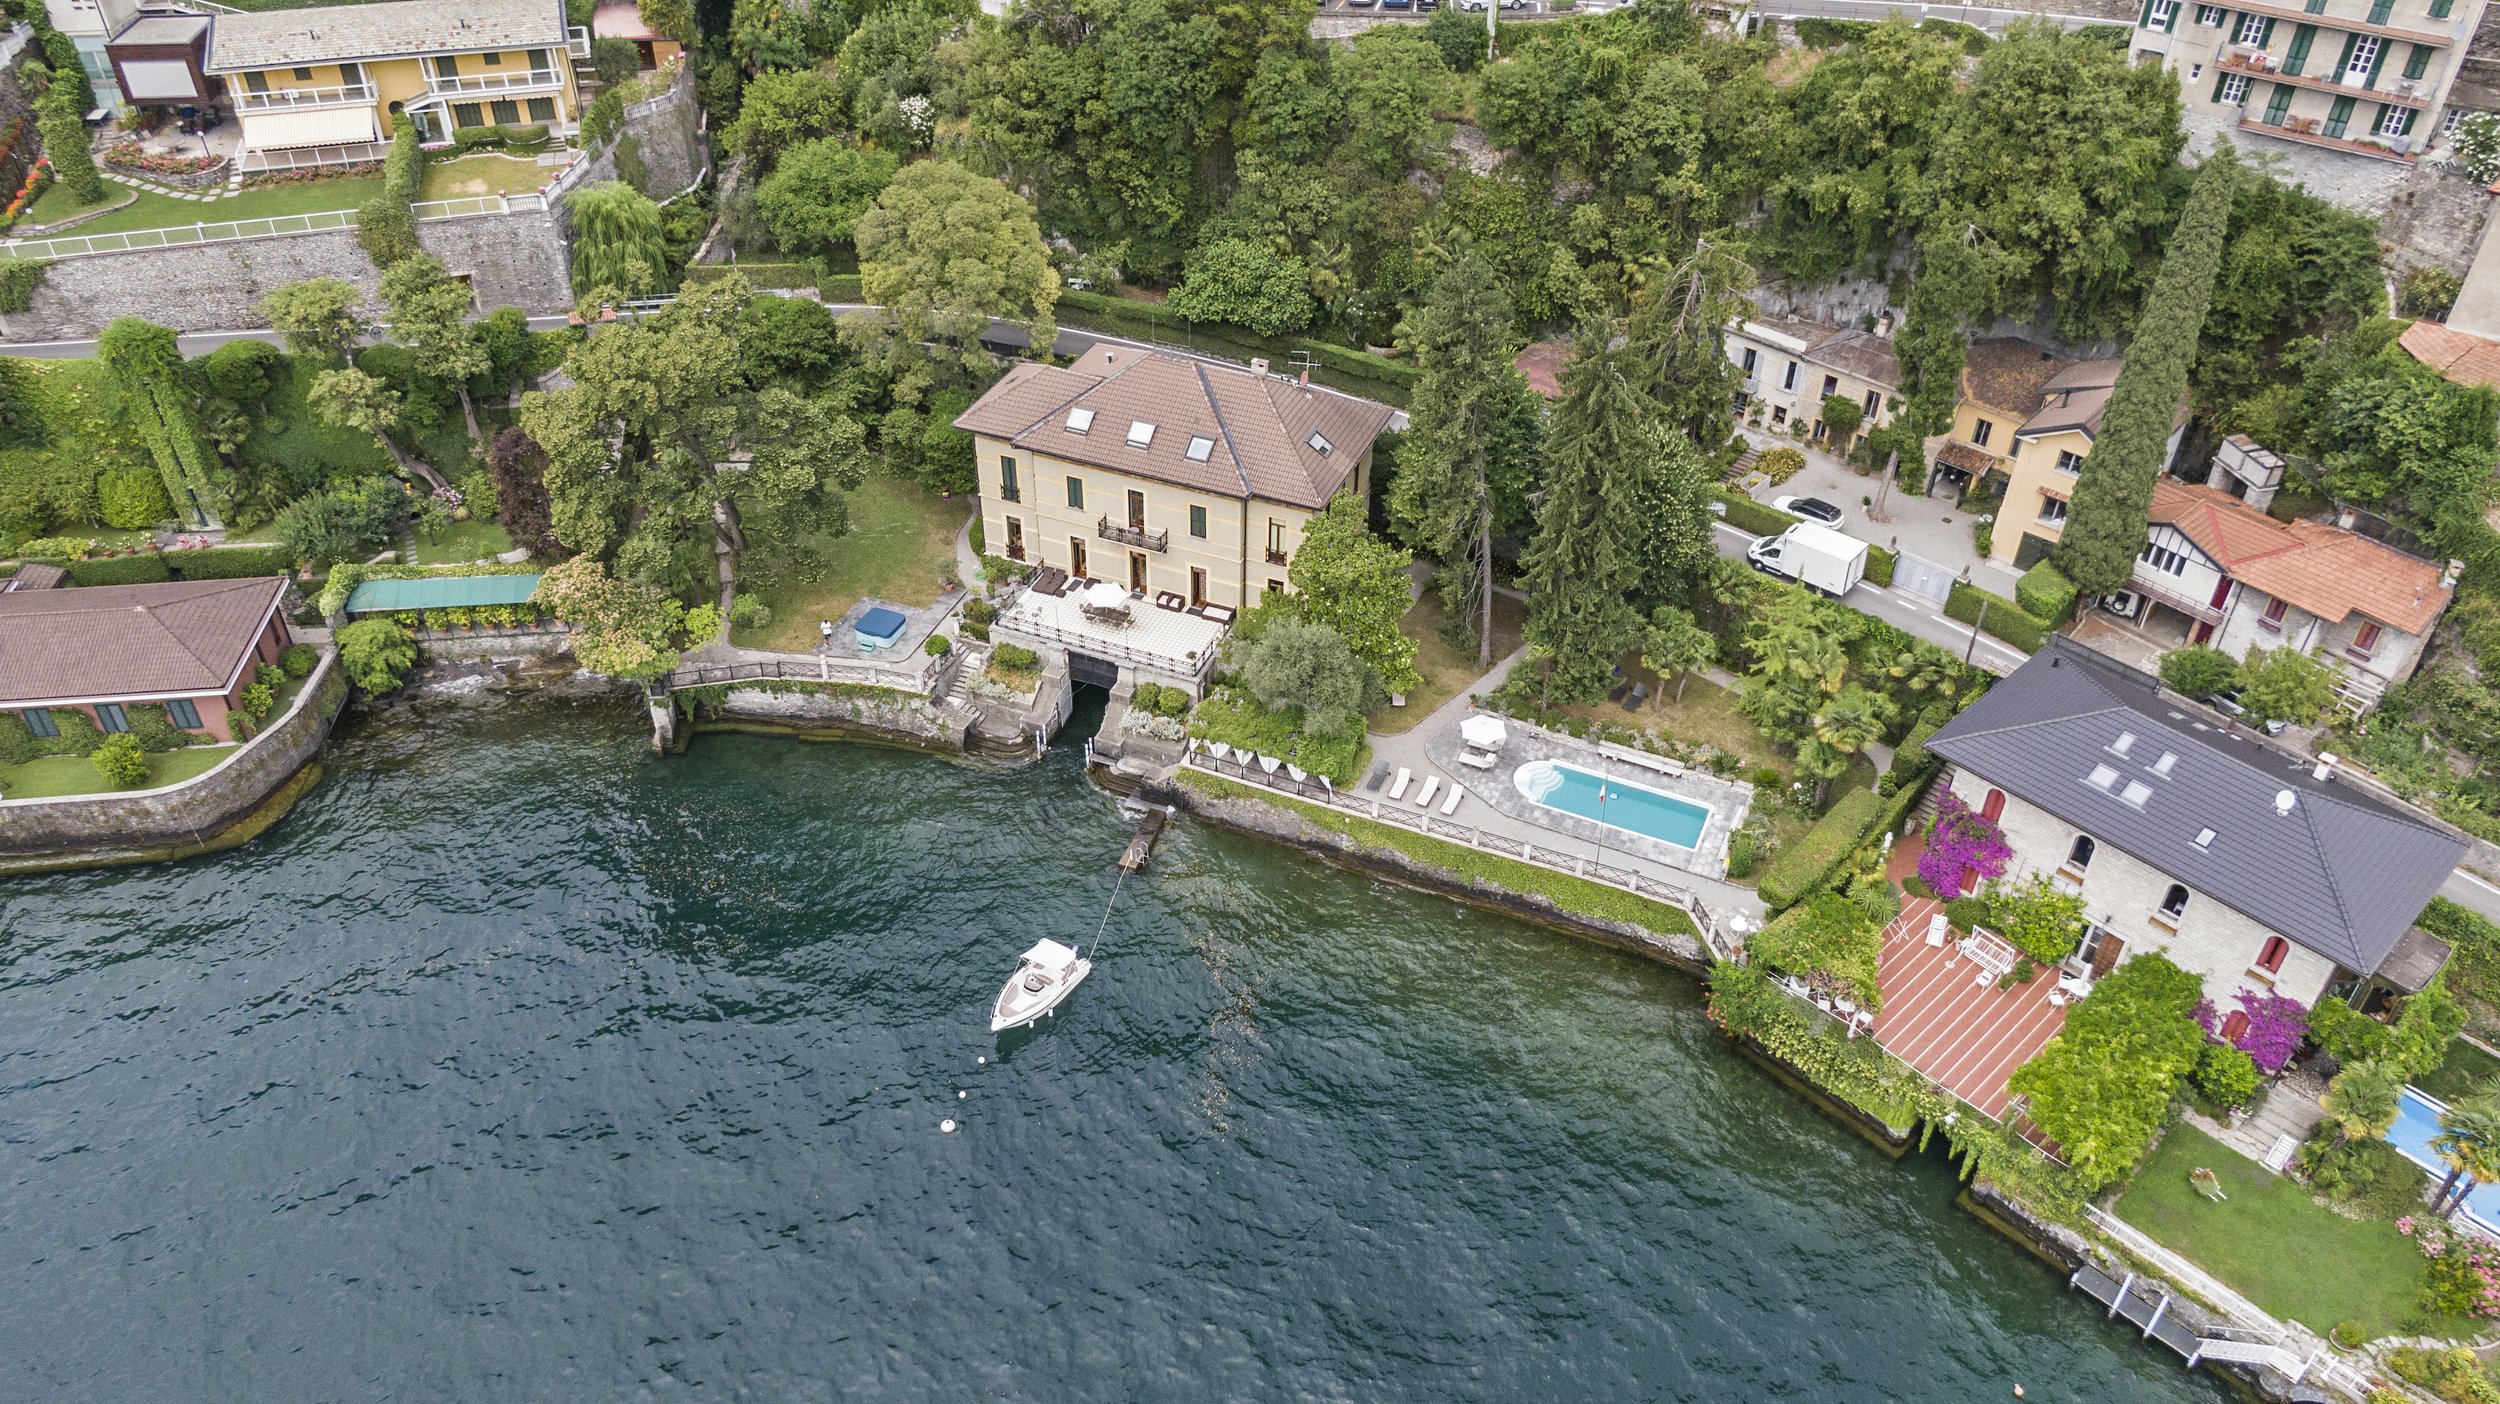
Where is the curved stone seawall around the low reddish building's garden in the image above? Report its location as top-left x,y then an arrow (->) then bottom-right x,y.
0,652 -> 348,872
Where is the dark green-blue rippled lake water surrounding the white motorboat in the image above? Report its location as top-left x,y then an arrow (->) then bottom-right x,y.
0,704 -> 2220,1402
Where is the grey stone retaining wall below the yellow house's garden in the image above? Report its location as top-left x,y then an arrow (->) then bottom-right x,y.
0,205 -> 573,340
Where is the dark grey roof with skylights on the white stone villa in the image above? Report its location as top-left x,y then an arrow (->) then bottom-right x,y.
1928,635 -> 2465,974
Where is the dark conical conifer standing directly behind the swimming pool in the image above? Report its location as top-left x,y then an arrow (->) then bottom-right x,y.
1520,322 -> 1660,702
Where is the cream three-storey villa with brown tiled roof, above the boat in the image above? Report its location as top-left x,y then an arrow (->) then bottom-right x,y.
955,345 -> 1393,610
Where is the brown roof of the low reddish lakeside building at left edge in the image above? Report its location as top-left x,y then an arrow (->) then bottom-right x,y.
0,577 -> 288,707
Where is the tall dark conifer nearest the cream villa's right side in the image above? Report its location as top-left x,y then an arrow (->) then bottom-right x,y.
1390,252 -> 1520,667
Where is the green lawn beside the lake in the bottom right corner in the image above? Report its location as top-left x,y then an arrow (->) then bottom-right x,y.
2118,1124 -> 2455,1337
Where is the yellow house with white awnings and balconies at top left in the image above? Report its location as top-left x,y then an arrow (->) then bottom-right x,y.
205,0 -> 590,170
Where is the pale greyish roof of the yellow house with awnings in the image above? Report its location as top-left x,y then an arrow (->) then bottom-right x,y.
208,0 -> 565,72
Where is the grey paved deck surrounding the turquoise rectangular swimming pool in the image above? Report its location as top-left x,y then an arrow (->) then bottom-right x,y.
1423,714 -> 1753,879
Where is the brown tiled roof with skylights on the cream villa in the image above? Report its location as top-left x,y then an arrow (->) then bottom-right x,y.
955,345 -> 1390,507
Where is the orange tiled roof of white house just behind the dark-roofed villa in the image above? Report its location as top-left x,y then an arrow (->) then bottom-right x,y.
2153,477 -> 2455,635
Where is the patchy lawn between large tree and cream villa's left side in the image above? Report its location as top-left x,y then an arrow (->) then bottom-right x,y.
733,472 -> 973,652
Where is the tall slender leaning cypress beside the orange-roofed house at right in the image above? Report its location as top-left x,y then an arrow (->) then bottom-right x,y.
2058,137 -> 2240,595
